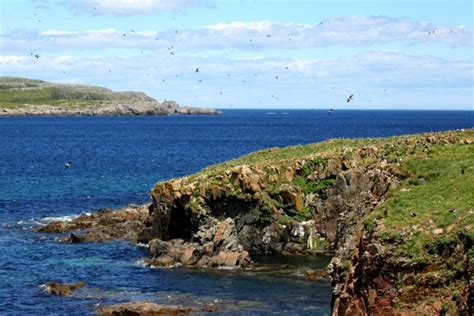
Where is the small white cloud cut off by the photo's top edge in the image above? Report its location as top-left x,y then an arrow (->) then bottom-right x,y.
63,0 -> 212,15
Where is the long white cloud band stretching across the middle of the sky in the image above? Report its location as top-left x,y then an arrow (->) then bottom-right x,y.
0,16 -> 474,53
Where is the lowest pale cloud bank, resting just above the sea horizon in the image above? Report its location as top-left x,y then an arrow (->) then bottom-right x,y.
0,50 -> 474,108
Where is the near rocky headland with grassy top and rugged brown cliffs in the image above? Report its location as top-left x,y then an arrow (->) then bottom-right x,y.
40,129 -> 474,315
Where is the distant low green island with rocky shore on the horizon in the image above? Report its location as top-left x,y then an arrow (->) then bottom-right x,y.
0,77 -> 221,116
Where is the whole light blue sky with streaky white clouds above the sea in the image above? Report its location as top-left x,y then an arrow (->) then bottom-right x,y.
0,0 -> 474,110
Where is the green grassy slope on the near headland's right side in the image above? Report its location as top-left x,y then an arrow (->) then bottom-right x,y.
365,137 -> 474,263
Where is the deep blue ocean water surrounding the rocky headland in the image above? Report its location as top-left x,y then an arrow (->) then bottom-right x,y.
0,110 -> 474,315
